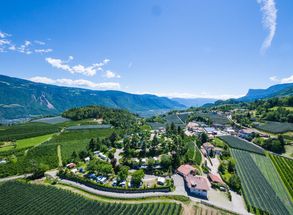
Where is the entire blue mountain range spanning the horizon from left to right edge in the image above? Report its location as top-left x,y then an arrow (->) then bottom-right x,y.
0,75 -> 293,120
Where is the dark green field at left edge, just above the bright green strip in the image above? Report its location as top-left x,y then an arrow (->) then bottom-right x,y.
0,122 -> 61,141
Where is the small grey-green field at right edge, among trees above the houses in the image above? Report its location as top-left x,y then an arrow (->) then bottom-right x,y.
255,121 -> 293,134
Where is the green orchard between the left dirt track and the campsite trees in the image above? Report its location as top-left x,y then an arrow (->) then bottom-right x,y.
48,129 -> 113,161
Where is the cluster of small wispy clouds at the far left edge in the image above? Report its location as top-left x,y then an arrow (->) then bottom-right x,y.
0,31 -> 52,55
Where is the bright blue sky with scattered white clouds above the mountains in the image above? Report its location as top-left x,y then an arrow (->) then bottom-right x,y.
0,0 -> 293,99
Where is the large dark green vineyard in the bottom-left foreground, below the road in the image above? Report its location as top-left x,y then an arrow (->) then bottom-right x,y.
0,182 -> 182,215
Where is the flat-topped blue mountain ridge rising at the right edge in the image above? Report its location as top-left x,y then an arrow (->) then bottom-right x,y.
237,83 -> 293,102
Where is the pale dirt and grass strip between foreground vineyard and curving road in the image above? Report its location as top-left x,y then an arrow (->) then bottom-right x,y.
55,184 -> 195,215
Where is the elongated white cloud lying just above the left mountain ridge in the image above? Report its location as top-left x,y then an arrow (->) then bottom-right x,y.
29,76 -> 120,89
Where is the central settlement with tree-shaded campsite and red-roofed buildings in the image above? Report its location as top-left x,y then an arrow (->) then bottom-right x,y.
61,111 -> 262,212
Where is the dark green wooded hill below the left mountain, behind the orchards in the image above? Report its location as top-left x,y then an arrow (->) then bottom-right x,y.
62,106 -> 137,128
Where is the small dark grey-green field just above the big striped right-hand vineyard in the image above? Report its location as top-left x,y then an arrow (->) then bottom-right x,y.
219,136 -> 264,154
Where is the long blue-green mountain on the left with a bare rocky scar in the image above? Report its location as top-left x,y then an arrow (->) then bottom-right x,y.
0,75 -> 185,119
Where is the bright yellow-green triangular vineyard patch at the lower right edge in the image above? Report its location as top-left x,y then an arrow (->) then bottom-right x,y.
269,154 -> 293,200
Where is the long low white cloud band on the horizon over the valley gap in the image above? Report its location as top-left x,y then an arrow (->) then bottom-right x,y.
134,92 -> 244,100
